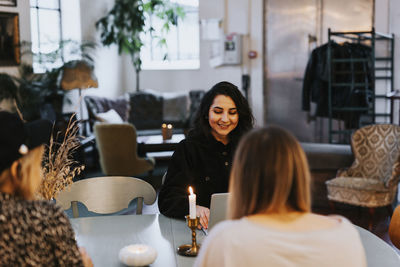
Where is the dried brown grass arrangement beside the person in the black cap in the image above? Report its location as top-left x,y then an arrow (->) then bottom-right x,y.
38,114 -> 85,200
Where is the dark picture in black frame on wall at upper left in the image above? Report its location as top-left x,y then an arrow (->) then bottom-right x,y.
0,12 -> 21,66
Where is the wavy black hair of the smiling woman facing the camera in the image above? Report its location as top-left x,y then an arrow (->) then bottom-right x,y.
191,82 -> 254,144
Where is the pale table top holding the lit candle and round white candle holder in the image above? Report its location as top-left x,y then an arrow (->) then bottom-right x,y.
71,215 -> 400,267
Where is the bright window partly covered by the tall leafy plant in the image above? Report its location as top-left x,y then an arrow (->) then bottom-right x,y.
140,0 -> 200,70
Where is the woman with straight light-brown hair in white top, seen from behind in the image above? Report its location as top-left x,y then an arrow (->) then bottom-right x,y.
195,126 -> 367,267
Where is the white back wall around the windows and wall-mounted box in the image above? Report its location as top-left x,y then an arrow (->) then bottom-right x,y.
0,0 -> 400,129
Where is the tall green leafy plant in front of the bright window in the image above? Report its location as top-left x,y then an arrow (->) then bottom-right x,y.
96,0 -> 184,91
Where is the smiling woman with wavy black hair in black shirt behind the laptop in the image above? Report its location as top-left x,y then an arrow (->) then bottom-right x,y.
158,82 -> 254,228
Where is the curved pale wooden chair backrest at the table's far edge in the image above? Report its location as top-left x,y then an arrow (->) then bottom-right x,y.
56,176 -> 157,217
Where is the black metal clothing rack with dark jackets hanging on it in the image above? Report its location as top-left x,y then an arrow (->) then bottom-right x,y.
327,28 -> 394,143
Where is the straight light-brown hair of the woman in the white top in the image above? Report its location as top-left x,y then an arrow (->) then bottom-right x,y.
228,126 -> 311,219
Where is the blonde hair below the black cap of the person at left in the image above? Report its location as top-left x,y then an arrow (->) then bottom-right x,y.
0,146 -> 44,199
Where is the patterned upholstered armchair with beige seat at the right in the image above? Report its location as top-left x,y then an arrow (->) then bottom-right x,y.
326,124 -> 400,211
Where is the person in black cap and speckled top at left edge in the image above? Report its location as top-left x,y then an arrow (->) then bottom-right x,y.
0,111 -> 93,266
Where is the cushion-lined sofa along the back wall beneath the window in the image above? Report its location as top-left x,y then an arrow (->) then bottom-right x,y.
84,89 -> 204,135
